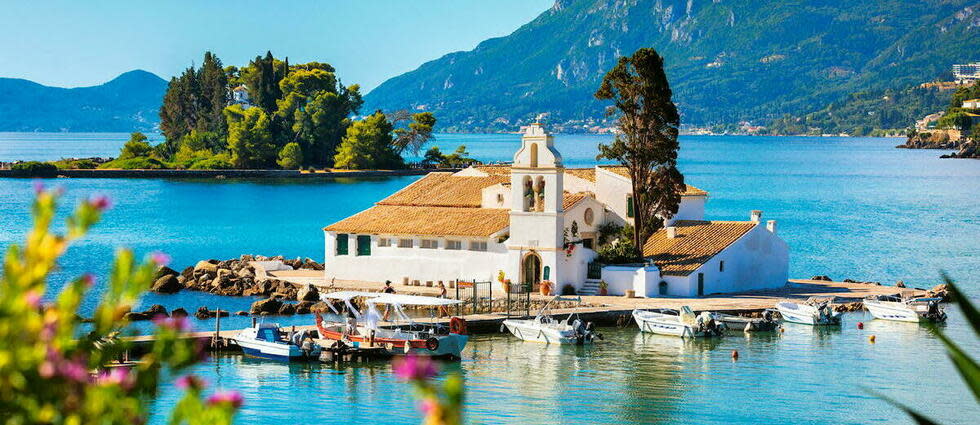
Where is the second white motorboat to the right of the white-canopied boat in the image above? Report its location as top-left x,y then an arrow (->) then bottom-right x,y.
633,306 -> 725,338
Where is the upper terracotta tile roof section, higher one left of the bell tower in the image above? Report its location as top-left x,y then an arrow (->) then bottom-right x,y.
378,173 -> 510,208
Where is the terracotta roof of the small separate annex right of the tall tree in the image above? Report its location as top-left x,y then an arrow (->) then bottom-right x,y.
643,220 -> 758,276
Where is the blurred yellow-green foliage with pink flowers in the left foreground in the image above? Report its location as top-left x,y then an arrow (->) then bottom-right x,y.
0,186 -> 241,425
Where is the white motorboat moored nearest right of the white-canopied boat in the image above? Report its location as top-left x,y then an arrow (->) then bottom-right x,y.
501,295 -> 601,345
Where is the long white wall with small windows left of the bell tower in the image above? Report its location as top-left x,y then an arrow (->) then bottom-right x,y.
324,232 -> 507,284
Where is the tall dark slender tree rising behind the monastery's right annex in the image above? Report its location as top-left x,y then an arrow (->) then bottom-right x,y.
595,48 -> 685,258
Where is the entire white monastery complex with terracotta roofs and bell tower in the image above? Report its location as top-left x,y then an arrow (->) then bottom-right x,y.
323,124 -> 789,297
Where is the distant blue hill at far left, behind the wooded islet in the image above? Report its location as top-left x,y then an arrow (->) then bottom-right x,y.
0,70 -> 167,131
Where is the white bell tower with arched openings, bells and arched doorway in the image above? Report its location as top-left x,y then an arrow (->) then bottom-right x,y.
505,123 -> 565,290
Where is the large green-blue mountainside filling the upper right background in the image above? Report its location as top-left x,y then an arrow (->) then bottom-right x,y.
364,0 -> 980,131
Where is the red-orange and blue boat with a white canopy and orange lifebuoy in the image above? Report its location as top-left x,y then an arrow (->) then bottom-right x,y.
316,291 -> 469,359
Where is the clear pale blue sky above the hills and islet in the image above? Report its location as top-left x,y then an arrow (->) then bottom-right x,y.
0,0 -> 554,91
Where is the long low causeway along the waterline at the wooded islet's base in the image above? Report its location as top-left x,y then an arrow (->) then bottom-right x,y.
0,168 -> 460,179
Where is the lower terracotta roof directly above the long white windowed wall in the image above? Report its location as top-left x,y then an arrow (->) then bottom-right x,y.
323,205 -> 510,237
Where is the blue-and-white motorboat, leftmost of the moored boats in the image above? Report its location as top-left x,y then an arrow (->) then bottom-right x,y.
232,321 -> 321,360
